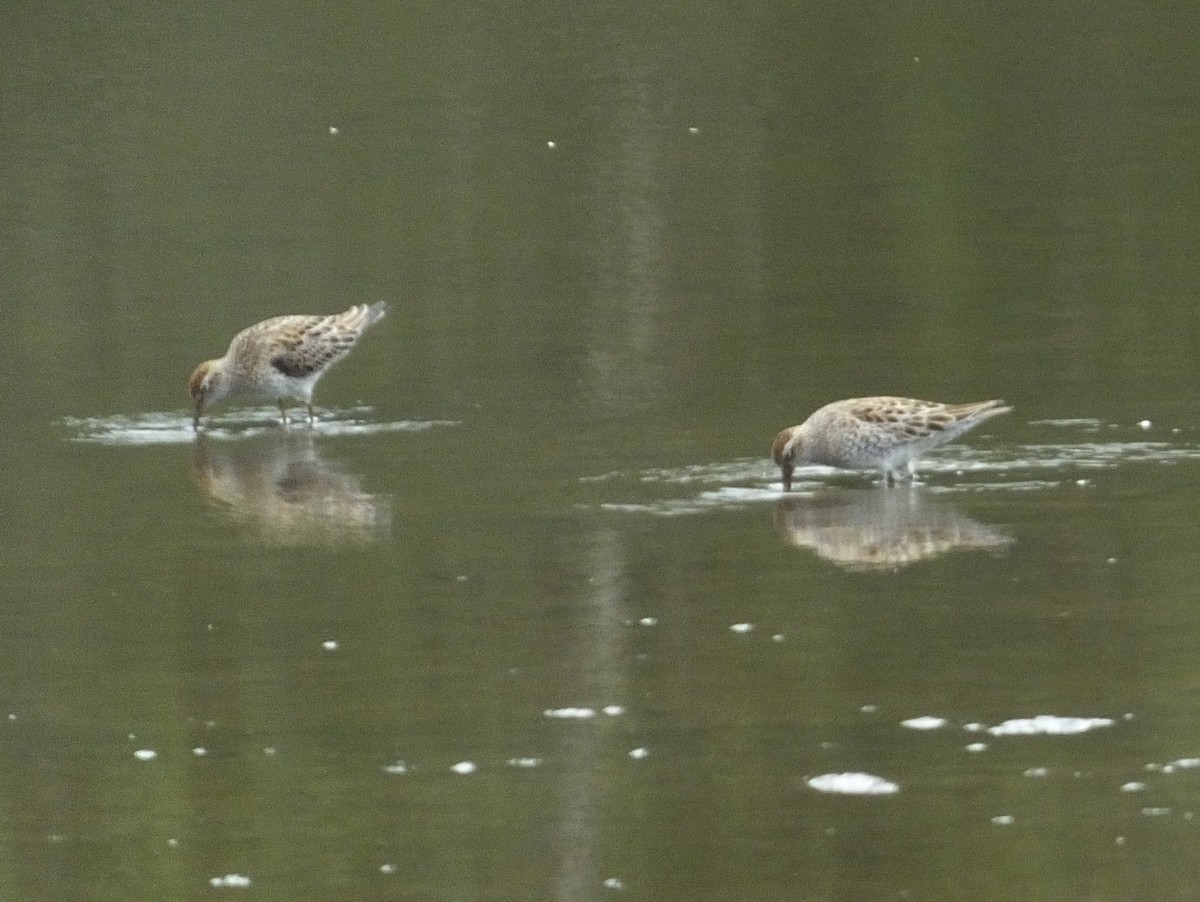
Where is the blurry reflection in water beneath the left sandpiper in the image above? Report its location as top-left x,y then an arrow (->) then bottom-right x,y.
192,431 -> 391,546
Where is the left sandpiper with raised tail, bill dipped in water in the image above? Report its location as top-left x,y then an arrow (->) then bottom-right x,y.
187,301 -> 388,429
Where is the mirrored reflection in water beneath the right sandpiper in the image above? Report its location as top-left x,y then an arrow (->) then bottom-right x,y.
775,488 -> 1014,570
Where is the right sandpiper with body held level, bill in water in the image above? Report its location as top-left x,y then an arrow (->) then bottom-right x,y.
770,397 -> 1012,492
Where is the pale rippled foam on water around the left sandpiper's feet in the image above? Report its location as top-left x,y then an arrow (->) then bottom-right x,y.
60,407 -> 461,445
